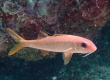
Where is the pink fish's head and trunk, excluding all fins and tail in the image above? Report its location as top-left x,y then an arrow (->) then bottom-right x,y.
26,35 -> 97,53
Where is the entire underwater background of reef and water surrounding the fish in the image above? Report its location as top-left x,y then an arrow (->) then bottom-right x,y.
0,0 -> 110,80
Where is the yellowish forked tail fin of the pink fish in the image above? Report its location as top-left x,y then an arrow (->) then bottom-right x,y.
6,28 -> 25,56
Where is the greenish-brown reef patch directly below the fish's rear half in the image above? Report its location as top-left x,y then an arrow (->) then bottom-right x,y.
12,48 -> 56,61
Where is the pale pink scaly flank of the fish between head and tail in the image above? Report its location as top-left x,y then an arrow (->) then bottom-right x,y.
27,36 -> 74,52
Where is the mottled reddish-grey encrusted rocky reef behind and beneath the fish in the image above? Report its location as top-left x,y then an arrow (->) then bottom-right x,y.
0,0 -> 110,60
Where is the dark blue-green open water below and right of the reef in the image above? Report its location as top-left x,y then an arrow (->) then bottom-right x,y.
0,22 -> 110,80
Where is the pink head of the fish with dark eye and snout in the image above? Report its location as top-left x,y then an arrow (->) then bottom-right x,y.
73,37 -> 97,53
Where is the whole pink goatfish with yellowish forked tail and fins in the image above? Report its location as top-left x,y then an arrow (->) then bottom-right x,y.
6,28 -> 97,65
